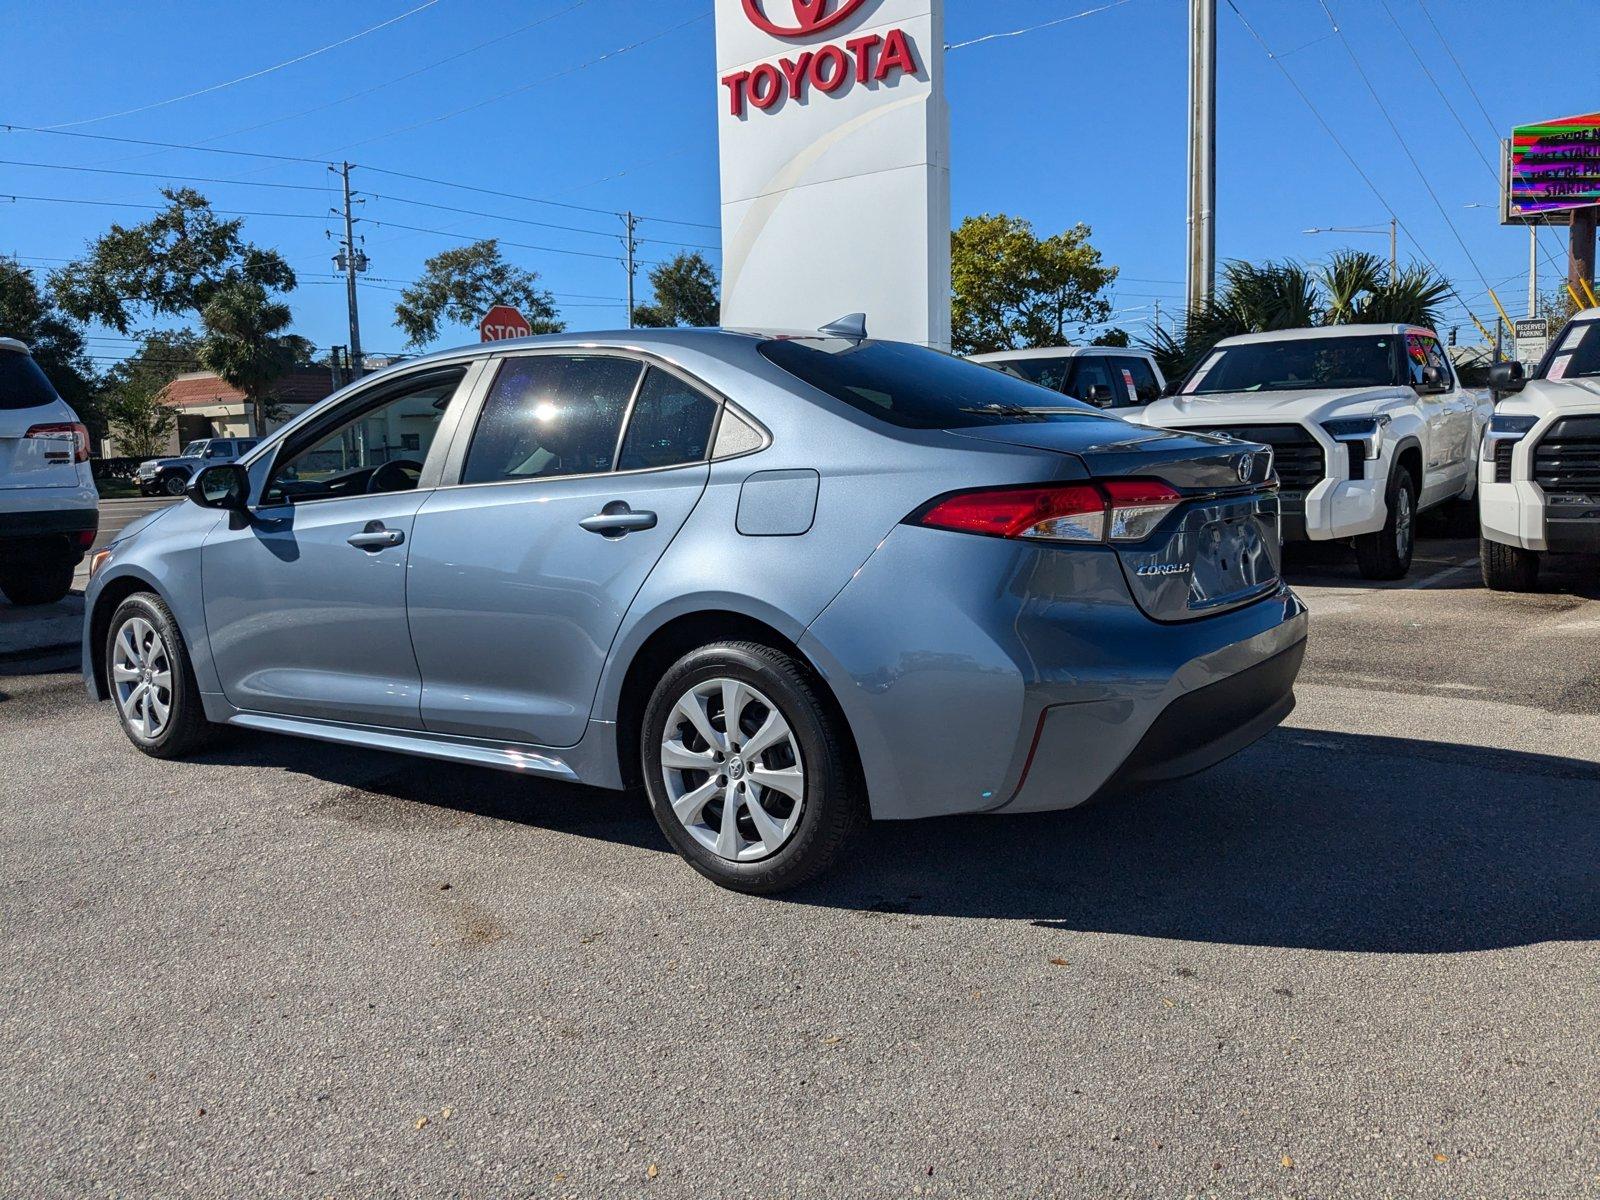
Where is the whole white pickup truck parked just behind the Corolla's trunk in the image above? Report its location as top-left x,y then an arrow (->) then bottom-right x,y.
1128,325 -> 1493,579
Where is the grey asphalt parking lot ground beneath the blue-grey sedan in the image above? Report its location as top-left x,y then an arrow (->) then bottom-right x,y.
0,508 -> 1600,1197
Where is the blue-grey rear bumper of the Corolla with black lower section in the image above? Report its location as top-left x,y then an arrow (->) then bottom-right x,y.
800,526 -> 1307,819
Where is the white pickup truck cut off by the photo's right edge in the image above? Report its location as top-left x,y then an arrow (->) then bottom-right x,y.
1478,309 -> 1600,592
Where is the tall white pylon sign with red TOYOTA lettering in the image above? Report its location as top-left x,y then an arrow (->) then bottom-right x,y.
715,0 -> 950,349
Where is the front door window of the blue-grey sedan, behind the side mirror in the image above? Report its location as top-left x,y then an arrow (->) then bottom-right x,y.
262,368 -> 466,504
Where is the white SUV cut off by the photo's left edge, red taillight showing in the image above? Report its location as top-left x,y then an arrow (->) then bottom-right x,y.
0,338 -> 99,605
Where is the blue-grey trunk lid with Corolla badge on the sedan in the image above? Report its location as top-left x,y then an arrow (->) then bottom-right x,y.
950,421 -> 1280,621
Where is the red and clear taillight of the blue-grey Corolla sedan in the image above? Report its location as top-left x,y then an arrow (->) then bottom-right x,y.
910,480 -> 1182,542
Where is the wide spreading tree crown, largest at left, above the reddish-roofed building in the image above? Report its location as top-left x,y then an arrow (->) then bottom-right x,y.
51,187 -> 294,333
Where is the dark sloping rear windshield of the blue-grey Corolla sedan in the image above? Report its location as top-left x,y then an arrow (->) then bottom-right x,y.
762,338 -> 1104,429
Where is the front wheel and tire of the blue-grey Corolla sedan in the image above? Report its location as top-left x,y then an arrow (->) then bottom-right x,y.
106,592 -> 213,758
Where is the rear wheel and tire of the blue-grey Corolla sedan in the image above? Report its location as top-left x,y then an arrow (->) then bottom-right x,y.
640,642 -> 866,894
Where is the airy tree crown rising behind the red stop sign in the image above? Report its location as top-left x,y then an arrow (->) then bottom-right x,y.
395,238 -> 566,347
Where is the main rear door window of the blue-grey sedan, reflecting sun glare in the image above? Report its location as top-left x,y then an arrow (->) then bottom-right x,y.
461,354 -> 640,483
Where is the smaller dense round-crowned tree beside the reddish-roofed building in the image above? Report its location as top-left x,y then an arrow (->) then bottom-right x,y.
200,280 -> 312,437
